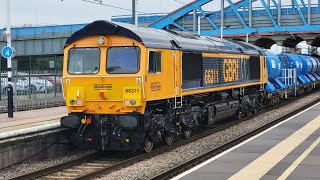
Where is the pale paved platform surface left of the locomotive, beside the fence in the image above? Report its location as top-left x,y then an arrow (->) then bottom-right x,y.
0,106 -> 68,133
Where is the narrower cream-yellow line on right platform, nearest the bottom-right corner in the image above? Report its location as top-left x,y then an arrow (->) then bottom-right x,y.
278,137 -> 320,180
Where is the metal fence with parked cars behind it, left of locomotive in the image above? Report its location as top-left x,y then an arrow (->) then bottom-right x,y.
0,55 -> 65,113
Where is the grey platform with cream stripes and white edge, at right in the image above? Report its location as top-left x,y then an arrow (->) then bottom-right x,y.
173,104 -> 320,180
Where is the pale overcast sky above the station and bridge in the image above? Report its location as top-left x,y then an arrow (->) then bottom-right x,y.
0,0 -> 310,29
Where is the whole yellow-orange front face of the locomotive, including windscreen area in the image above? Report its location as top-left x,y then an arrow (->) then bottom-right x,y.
63,36 -> 146,114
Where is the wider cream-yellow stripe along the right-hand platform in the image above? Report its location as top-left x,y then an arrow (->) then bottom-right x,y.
229,116 -> 320,180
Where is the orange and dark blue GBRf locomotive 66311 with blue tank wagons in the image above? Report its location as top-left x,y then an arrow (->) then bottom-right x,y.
61,20 -> 320,152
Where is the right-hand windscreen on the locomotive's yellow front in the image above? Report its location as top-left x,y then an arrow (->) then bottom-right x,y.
107,46 -> 140,74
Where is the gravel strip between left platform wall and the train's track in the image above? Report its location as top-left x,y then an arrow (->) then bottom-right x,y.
0,151 -> 91,179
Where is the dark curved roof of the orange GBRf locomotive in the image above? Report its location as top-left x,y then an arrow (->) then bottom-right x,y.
66,20 -> 263,55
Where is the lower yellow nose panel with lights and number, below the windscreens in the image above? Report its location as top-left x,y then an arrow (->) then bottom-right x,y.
64,76 -> 145,114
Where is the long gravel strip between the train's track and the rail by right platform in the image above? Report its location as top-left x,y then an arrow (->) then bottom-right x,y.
97,93 -> 320,180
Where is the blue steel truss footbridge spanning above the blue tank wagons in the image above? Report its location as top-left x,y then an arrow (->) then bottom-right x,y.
148,0 -> 320,49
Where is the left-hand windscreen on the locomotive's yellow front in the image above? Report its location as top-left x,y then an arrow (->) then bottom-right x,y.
68,48 -> 100,74
